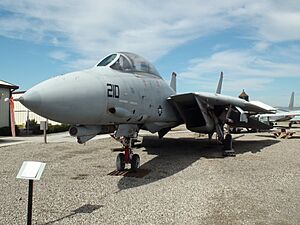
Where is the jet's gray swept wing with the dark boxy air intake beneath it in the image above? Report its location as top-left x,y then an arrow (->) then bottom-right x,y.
169,92 -> 275,136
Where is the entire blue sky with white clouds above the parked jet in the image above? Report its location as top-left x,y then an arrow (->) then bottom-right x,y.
0,0 -> 300,106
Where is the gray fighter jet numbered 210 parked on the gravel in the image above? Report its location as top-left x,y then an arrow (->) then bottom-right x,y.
20,52 -> 274,170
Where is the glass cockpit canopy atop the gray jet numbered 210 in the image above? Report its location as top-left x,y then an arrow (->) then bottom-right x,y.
97,52 -> 160,77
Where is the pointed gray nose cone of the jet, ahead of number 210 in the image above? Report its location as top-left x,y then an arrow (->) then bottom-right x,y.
20,71 -> 106,124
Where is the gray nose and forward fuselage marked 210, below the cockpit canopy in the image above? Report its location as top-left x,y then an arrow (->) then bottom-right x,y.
21,57 -> 178,132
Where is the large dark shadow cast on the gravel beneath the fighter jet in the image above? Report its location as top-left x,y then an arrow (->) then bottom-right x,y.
118,136 -> 279,190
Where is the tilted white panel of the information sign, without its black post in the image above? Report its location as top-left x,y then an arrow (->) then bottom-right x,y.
17,161 -> 46,180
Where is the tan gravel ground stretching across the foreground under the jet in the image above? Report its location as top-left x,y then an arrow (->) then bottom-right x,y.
0,132 -> 300,225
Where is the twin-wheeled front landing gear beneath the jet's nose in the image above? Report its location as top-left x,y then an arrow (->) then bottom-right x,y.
116,137 -> 140,171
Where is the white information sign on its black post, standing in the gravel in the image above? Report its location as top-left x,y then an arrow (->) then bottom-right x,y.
17,161 -> 46,225
